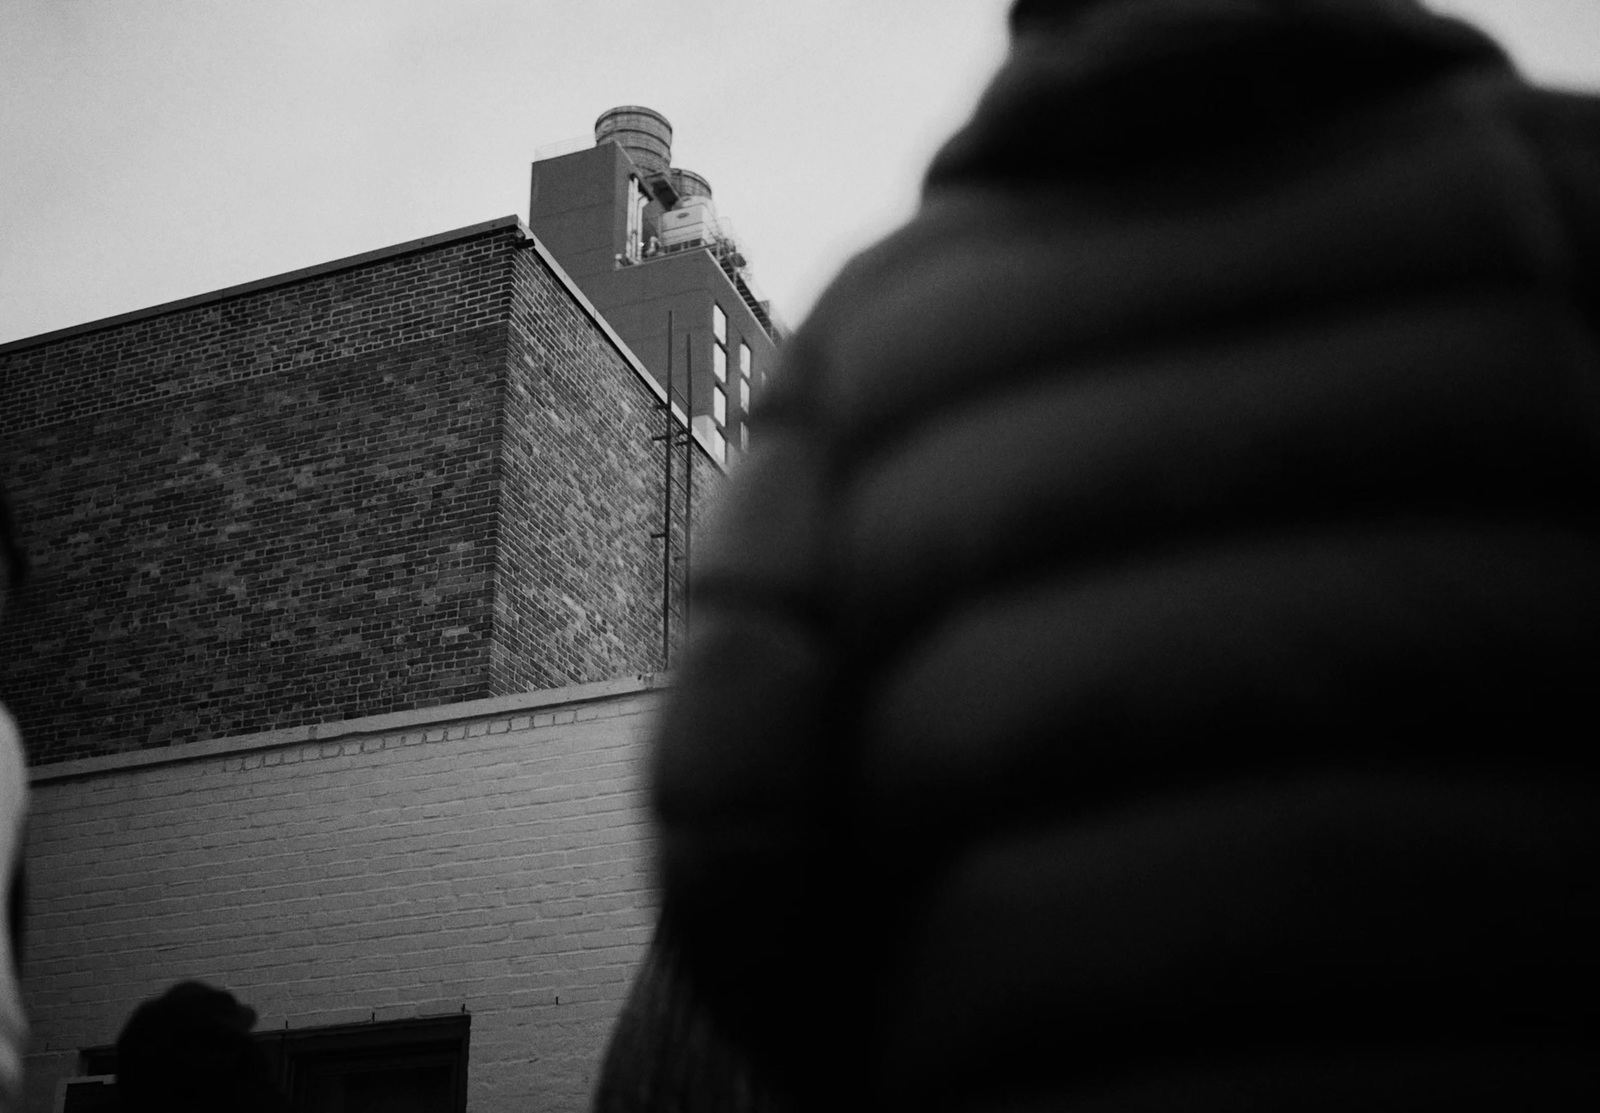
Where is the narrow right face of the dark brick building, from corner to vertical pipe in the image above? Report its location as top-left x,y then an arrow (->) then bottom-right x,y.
494,251 -> 675,692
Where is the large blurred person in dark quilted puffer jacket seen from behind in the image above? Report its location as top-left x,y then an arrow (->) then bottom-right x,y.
598,0 -> 1600,1113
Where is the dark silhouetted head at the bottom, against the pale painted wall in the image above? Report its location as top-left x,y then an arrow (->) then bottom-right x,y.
117,982 -> 290,1113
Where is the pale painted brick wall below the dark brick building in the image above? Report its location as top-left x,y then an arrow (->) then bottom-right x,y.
15,689 -> 658,1113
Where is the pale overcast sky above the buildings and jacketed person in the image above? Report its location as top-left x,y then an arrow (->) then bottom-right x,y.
0,0 -> 1600,342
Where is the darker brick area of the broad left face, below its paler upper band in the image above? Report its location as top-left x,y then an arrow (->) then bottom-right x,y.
0,328 -> 504,761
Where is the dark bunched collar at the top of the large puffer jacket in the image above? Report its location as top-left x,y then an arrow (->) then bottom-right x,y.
926,0 -> 1509,190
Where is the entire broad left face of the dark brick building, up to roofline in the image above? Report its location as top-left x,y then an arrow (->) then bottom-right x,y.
0,233 -> 510,763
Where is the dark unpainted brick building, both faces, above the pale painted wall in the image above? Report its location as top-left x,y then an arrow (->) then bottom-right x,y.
0,227 -> 715,763
